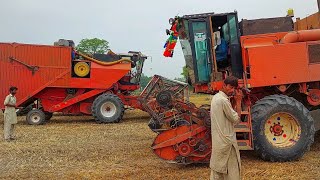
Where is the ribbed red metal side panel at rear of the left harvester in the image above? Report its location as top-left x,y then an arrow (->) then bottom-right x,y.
0,43 -> 71,108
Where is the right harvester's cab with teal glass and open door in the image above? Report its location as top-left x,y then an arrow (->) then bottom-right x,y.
179,12 -> 243,87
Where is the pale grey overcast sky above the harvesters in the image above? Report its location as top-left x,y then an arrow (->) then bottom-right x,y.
0,0 -> 317,78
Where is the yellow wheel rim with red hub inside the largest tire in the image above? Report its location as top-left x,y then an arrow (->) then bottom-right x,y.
264,112 -> 301,148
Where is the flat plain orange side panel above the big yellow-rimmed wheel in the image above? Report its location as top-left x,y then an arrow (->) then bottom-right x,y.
248,43 -> 310,87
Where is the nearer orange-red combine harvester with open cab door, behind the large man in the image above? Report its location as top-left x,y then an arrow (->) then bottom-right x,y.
147,12 -> 320,164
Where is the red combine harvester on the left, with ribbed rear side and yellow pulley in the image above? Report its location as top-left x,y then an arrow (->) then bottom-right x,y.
0,40 -> 147,125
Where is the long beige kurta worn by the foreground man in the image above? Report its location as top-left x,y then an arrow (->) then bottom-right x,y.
210,91 -> 241,179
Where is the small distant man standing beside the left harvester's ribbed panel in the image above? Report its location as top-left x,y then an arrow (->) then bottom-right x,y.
4,87 -> 18,141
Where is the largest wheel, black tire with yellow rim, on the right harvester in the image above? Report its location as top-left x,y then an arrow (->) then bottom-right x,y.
252,95 -> 315,162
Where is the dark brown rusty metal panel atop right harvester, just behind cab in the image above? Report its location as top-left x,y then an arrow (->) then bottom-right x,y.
239,17 -> 294,36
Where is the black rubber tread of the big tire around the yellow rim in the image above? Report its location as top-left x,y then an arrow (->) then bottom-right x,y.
251,95 -> 315,162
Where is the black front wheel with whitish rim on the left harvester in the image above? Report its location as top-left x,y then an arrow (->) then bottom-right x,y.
92,94 -> 124,123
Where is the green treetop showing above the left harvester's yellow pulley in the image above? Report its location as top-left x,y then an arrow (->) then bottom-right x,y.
76,38 -> 109,54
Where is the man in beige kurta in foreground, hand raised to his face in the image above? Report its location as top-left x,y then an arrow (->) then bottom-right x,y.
210,76 -> 242,180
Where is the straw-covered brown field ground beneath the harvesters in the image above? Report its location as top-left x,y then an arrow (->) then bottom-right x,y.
0,96 -> 320,179
